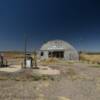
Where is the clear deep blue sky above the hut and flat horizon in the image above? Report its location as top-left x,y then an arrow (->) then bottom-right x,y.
0,0 -> 100,51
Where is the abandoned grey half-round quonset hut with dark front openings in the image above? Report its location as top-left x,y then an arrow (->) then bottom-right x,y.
40,40 -> 79,60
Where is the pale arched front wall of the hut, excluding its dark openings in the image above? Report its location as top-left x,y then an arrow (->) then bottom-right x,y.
40,40 -> 79,60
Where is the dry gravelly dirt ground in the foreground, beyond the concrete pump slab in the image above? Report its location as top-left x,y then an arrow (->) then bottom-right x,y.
0,63 -> 100,100
